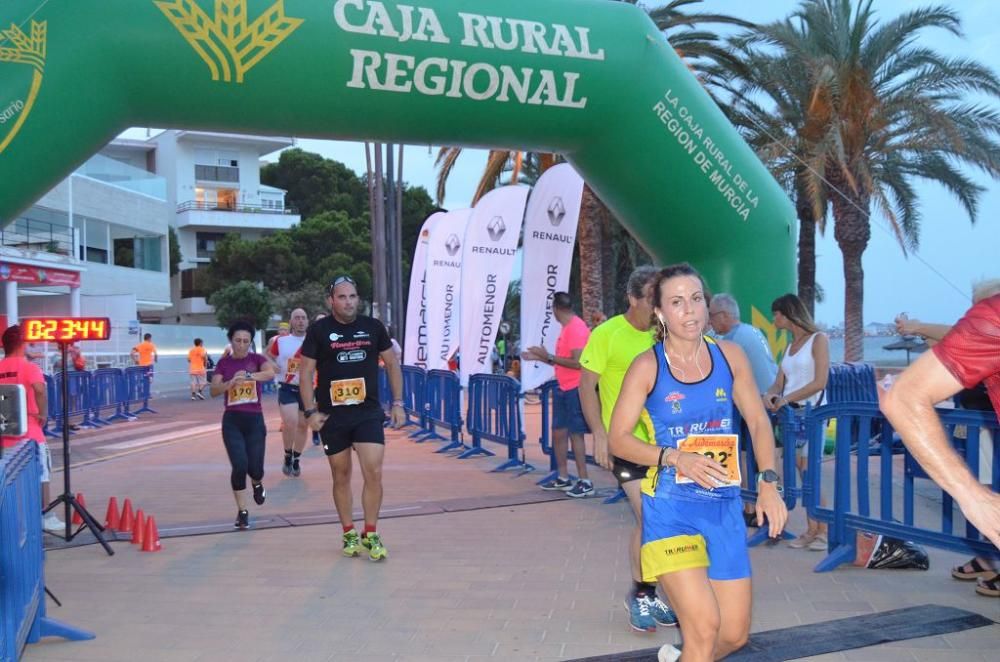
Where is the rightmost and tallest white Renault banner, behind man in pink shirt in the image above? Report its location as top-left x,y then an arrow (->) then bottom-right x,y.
520,163 -> 583,391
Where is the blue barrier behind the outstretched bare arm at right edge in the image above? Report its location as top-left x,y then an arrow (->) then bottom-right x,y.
803,403 -> 1000,572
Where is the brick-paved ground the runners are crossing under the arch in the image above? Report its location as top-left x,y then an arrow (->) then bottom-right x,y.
24,394 -> 1000,662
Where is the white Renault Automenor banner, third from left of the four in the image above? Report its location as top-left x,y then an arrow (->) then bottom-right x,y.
458,186 -> 529,386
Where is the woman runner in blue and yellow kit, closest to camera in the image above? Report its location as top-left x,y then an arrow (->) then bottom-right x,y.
608,264 -> 788,662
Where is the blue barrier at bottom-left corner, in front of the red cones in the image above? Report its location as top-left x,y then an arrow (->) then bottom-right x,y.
0,441 -> 94,660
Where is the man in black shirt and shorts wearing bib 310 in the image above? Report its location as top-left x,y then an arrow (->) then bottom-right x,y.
299,276 -> 406,561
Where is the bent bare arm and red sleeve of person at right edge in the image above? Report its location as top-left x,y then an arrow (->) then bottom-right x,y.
883,294 -> 1000,572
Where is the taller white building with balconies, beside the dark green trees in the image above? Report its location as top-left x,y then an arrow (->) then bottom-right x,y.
148,130 -> 301,325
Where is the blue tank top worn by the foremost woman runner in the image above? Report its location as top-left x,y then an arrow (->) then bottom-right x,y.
642,336 -> 740,501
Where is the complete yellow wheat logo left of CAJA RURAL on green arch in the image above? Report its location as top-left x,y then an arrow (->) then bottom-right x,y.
154,0 -> 303,83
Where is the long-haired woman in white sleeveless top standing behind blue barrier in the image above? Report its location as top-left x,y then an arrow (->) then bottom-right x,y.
763,294 -> 830,552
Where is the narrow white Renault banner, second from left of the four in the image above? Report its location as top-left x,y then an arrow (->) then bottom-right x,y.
424,209 -> 472,370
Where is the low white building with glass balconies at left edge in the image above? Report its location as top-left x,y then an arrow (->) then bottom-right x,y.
0,148 -> 172,326
